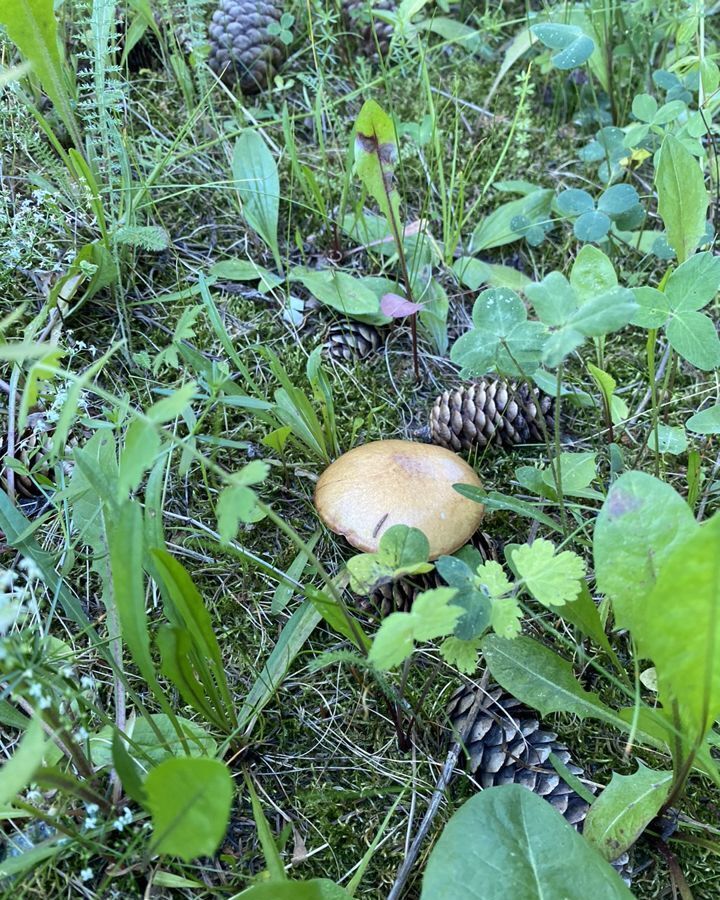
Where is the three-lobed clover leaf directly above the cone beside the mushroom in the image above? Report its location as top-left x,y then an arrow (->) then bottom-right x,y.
450,288 -> 545,378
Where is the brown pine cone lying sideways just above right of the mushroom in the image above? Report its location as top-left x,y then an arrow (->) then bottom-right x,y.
429,378 -> 554,452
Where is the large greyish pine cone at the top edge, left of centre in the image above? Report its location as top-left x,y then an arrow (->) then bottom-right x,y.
208,0 -> 283,94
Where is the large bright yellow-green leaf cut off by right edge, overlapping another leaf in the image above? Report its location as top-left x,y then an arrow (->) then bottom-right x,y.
632,513 -> 720,741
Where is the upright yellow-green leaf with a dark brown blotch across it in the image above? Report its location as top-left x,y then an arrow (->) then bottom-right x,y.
355,100 -> 400,235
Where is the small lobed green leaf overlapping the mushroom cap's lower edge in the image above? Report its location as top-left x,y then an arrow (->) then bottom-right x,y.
347,525 -> 433,594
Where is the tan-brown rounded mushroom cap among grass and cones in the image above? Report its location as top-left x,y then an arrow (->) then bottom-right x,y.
315,441 -> 484,559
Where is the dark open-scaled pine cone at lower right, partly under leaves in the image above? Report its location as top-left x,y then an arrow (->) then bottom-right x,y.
448,685 -> 631,883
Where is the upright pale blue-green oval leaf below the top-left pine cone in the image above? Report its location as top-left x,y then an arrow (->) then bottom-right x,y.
232,129 -> 282,271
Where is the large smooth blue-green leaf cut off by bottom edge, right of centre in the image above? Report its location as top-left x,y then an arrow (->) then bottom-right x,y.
420,784 -> 633,900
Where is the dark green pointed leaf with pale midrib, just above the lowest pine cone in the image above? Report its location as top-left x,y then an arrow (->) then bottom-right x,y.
481,634 -> 624,727
